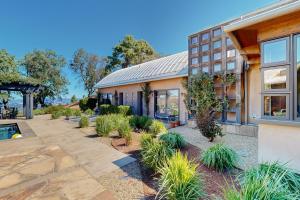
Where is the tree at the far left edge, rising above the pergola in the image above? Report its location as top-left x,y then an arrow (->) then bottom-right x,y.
0,49 -> 18,73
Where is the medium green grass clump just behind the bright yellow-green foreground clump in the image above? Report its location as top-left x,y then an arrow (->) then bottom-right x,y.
141,140 -> 174,172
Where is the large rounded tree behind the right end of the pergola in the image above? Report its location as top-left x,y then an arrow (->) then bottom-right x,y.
22,50 -> 68,106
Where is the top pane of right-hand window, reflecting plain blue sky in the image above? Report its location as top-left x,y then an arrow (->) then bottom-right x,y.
263,39 -> 288,64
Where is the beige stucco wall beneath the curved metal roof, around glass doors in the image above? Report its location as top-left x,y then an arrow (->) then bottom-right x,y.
99,78 -> 188,124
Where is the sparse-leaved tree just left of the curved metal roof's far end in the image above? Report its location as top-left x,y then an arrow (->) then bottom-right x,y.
70,49 -> 108,96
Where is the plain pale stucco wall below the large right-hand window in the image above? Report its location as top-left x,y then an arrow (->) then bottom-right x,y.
258,124 -> 300,172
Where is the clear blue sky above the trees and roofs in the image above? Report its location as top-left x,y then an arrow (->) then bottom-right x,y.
0,0 -> 277,98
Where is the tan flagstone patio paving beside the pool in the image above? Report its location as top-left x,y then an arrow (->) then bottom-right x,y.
0,116 -> 135,200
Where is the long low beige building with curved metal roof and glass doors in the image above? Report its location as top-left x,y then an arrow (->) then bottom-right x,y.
95,51 -> 188,124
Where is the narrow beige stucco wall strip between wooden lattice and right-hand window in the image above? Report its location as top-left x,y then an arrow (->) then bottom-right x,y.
248,65 -> 261,123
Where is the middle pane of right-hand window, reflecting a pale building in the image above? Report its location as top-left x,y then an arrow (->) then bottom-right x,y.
264,68 -> 288,90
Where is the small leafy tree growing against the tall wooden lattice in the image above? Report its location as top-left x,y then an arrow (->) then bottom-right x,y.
184,73 -> 223,142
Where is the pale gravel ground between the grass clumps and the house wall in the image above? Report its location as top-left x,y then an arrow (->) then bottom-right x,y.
170,126 -> 258,170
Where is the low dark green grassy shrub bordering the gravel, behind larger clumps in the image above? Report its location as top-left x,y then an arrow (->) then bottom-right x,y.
159,132 -> 186,149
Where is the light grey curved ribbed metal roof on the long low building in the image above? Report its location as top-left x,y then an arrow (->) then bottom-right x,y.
95,51 -> 188,88
